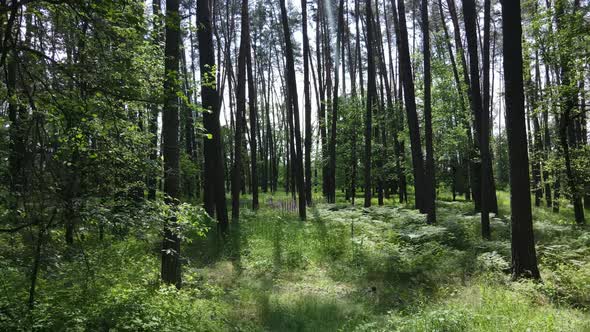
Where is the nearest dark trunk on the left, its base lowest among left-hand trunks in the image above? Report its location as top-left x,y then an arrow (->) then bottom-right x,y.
162,0 -> 181,288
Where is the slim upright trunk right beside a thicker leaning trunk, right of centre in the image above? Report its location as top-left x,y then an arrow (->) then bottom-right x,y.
421,0 -> 436,224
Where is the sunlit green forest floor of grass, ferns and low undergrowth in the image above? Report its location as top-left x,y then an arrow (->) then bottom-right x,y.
0,193 -> 590,331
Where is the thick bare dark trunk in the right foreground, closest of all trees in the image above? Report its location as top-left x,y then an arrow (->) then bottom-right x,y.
502,0 -> 540,279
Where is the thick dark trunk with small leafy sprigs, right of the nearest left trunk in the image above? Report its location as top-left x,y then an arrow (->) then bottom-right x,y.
197,0 -> 229,232
